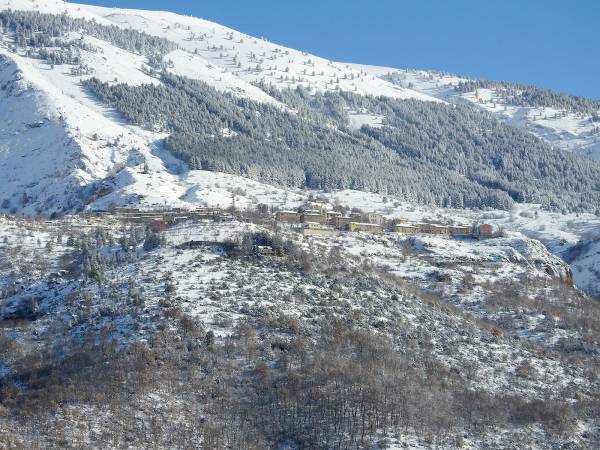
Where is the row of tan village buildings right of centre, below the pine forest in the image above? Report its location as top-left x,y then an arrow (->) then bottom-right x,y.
275,209 -> 495,238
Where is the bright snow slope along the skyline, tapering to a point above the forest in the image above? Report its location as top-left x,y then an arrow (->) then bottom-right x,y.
0,0 -> 439,102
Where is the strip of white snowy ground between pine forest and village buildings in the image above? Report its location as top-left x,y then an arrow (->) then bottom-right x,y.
90,171 -> 600,295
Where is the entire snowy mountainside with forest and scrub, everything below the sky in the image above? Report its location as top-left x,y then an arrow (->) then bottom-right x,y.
0,0 -> 600,450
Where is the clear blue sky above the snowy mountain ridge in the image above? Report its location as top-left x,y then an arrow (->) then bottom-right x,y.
71,0 -> 600,99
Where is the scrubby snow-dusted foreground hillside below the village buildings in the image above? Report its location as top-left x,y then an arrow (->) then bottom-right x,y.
0,215 -> 600,450
